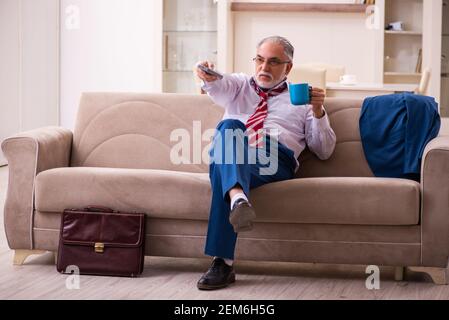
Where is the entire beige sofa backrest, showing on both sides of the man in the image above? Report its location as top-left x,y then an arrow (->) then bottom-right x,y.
71,93 -> 372,177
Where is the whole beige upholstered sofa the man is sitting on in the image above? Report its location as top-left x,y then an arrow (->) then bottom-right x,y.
2,93 -> 449,283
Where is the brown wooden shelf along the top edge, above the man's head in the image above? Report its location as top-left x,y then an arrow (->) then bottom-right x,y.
231,2 -> 368,13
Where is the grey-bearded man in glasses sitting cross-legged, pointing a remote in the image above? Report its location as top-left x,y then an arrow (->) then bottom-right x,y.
197,36 -> 336,290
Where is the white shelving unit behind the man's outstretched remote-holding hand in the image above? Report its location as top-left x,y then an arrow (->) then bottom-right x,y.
162,0 -> 217,93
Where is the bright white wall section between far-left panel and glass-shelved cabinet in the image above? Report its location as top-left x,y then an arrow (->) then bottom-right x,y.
61,0 -> 162,129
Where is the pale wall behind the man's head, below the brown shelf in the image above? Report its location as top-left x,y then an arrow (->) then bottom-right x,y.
234,12 -> 383,83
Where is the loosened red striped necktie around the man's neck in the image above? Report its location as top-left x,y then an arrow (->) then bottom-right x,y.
245,78 -> 288,148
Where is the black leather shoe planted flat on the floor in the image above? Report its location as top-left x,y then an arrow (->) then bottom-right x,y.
197,258 -> 235,290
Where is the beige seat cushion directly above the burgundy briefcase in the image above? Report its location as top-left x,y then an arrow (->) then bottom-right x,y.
35,167 -> 211,219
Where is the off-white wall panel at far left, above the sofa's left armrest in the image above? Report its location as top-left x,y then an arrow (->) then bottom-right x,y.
0,0 -> 59,164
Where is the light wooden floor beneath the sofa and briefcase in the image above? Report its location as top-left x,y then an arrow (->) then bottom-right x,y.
0,167 -> 449,300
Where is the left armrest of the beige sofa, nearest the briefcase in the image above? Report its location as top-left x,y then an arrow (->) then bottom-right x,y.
2,127 -> 73,249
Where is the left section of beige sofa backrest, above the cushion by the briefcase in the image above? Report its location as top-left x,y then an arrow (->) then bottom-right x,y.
71,93 -> 223,172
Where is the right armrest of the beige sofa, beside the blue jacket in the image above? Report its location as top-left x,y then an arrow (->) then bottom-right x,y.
421,137 -> 449,267
